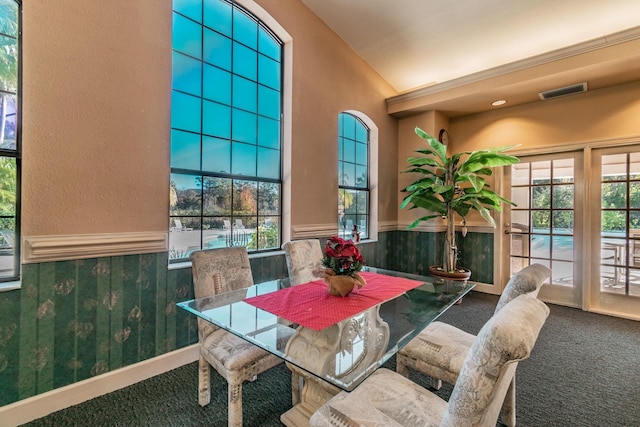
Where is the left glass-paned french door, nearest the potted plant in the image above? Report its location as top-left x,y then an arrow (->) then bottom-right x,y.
501,152 -> 584,307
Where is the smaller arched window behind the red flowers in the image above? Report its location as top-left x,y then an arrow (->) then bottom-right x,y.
338,113 -> 370,239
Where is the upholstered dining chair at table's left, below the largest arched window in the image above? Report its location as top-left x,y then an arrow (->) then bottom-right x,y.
189,246 -> 290,427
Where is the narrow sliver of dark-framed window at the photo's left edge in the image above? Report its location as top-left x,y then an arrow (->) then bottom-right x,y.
0,0 -> 21,281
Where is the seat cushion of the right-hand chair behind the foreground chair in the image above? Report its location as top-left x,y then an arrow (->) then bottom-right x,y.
400,322 -> 476,384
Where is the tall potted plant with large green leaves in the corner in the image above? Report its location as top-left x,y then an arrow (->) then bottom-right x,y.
400,127 -> 520,279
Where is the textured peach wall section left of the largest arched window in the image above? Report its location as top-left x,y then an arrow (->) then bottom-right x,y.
22,0 -> 171,236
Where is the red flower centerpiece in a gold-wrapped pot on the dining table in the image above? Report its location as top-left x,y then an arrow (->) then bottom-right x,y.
322,236 -> 367,296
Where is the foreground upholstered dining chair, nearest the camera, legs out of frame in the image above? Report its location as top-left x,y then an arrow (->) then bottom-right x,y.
310,295 -> 549,427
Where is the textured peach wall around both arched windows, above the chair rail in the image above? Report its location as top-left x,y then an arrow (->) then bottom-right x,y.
22,0 -> 397,236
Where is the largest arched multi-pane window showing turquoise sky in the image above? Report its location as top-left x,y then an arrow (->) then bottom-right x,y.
169,0 -> 282,261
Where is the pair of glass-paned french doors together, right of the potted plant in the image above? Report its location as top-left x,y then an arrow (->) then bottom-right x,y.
500,145 -> 640,320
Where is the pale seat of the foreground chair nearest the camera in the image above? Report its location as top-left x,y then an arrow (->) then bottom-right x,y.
311,368 -> 447,427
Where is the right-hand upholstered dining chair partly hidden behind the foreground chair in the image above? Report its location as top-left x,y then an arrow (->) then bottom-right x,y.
396,264 -> 551,426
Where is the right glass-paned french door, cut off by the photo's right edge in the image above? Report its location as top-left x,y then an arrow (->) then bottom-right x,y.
586,145 -> 640,319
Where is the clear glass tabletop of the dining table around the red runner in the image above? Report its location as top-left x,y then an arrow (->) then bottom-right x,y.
178,267 -> 475,391
